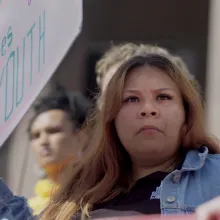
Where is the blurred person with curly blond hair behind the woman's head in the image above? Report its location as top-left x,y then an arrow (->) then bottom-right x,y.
95,43 -> 199,93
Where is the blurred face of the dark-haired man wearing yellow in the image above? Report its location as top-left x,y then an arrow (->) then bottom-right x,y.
30,110 -> 79,168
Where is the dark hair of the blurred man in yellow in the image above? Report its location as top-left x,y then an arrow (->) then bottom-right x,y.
28,88 -> 91,134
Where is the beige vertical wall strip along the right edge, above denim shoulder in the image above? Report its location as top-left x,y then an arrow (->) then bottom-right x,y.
206,0 -> 220,138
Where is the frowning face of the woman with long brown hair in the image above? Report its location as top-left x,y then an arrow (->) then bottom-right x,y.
115,66 -> 185,164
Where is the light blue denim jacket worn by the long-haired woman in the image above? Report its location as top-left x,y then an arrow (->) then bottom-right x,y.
158,147 -> 220,214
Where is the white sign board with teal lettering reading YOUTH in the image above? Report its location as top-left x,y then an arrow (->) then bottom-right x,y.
0,0 -> 82,146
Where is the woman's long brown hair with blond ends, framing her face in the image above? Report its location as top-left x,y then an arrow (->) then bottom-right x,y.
41,54 -> 219,220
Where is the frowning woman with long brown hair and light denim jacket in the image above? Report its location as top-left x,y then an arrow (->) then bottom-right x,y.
40,54 -> 220,220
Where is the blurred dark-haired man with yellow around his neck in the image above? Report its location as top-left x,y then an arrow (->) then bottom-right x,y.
28,89 -> 90,214
